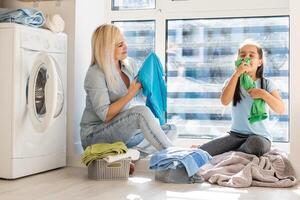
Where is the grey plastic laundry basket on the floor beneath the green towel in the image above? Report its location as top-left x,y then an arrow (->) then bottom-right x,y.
88,159 -> 130,180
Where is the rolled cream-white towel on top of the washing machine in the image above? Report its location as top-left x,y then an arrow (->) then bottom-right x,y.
44,14 -> 65,33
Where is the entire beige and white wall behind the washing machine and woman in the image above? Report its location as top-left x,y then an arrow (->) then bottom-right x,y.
0,0 -> 105,166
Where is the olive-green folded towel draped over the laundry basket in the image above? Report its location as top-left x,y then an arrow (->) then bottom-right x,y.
81,142 -> 128,166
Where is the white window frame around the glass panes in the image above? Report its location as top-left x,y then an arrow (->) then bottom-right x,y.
105,0 -> 291,152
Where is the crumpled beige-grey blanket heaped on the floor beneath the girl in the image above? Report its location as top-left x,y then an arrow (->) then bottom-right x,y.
197,150 -> 297,188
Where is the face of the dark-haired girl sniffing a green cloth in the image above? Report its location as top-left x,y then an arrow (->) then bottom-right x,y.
239,44 -> 263,72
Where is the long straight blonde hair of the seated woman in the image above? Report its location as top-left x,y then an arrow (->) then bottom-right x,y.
91,24 -> 122,91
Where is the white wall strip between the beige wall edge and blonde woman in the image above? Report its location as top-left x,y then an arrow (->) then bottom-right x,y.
68,0 -> 105,166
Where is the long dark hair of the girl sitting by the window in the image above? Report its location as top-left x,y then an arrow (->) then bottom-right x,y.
233,40 -> 264,106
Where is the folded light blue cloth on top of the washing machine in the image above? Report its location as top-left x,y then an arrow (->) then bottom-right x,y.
0,8 -> 45,27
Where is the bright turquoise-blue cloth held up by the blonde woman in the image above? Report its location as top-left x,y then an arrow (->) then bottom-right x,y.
138,52 -> 167,125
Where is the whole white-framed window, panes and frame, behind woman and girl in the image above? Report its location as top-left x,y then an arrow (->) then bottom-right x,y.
107,0 -> 289,142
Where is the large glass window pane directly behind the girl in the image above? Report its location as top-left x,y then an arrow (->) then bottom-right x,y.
166,17 -> 289,141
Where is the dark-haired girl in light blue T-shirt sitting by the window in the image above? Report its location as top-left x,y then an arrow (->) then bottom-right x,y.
199,41 -> 284,156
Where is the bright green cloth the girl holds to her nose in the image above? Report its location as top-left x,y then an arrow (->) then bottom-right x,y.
235,58 -> 268,124
